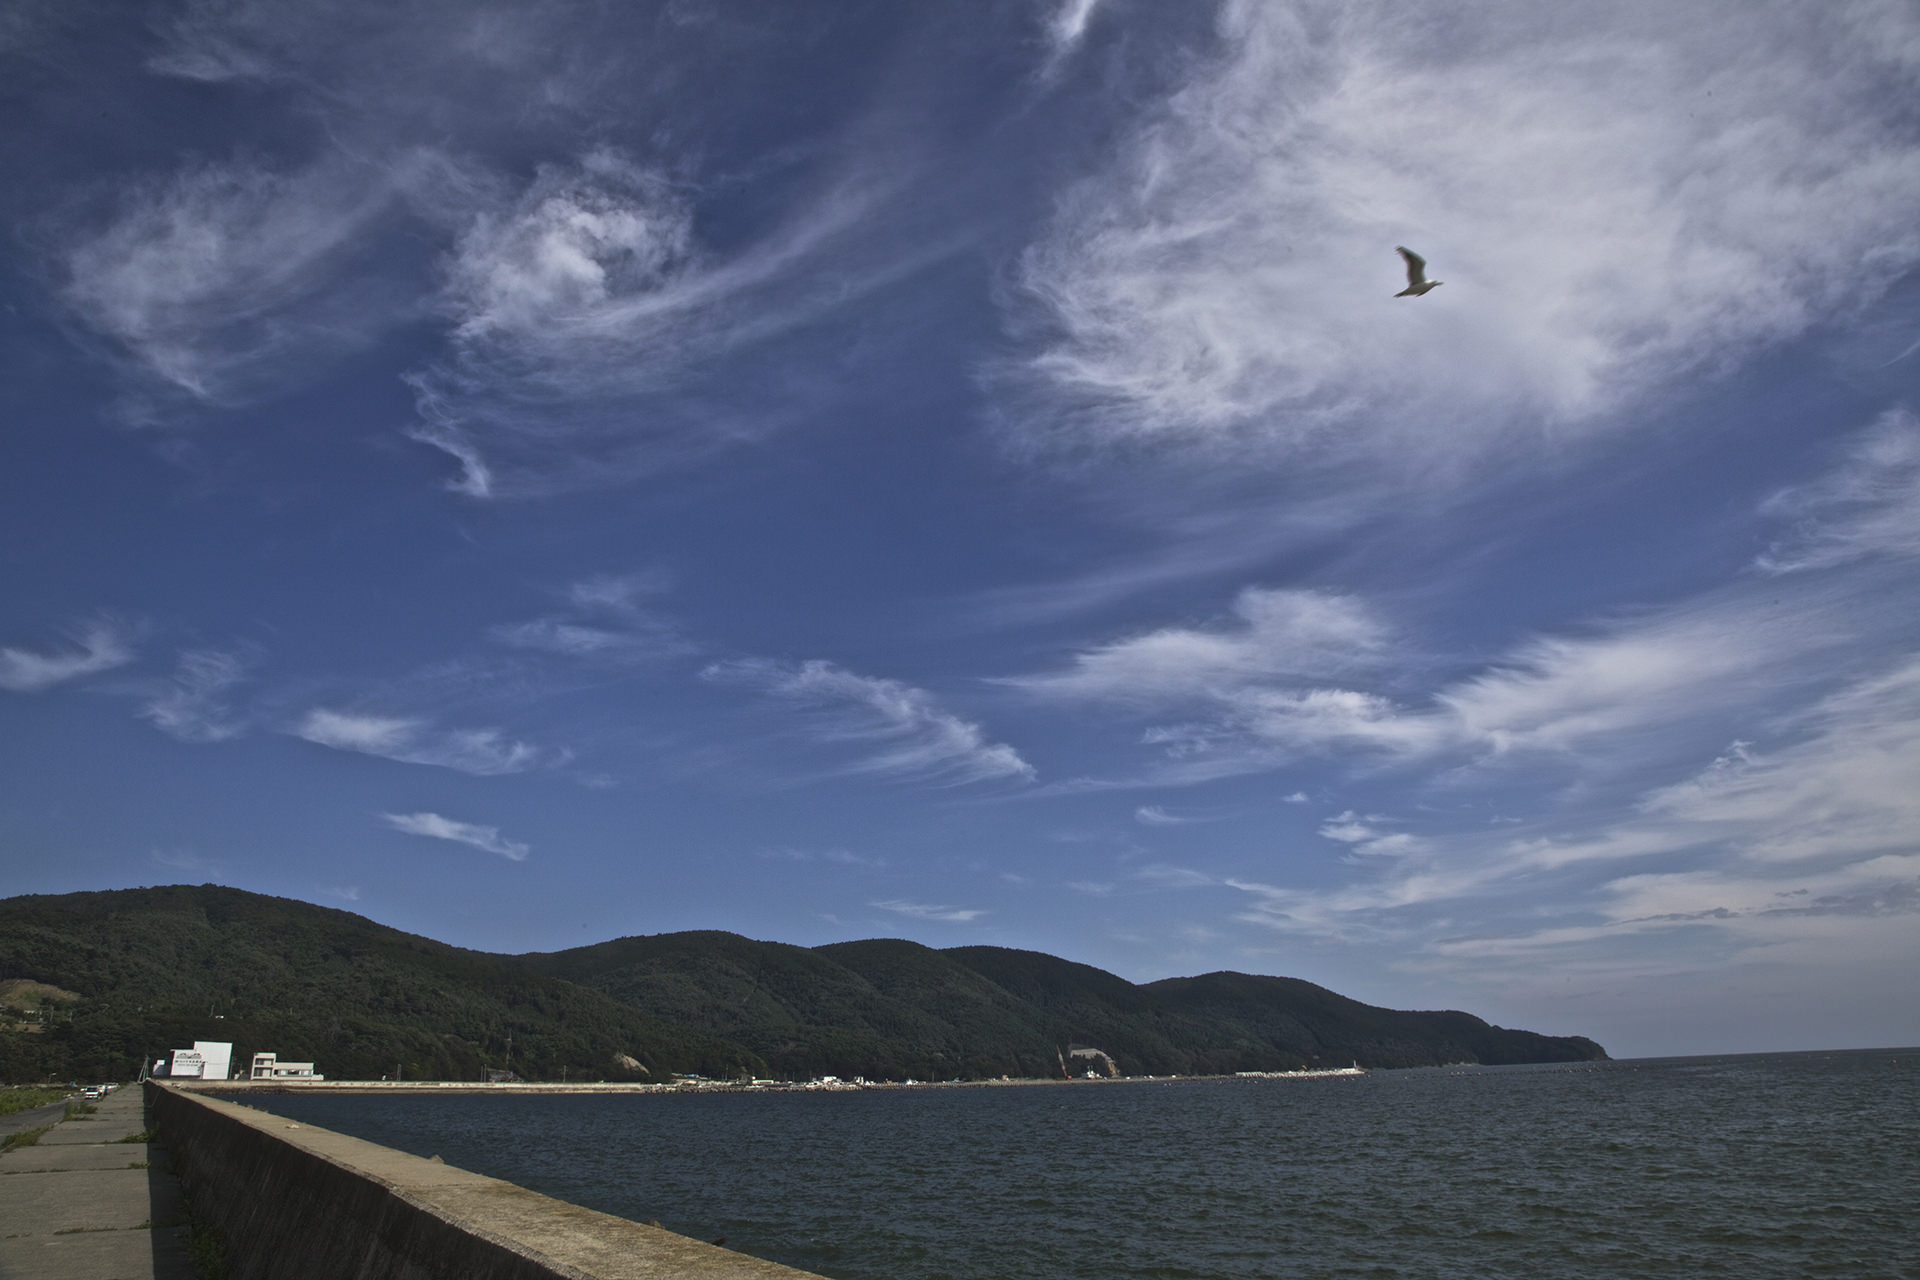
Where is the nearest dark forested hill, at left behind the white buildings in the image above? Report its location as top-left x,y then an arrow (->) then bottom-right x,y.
0,885 -> 762,1080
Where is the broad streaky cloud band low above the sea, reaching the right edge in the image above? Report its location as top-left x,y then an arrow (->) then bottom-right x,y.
1231,656 -> 1920,960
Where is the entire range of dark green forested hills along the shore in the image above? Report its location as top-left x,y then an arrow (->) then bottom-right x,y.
0,885 -> 1605,1080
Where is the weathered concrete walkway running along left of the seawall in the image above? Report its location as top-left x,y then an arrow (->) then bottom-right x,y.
0,1086 -> 194,1280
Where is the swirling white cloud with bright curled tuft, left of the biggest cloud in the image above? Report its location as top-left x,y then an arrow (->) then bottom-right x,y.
409,150 -> 887,497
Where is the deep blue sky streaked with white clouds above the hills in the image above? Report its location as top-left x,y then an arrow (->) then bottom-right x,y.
0,0 -> 1920,1055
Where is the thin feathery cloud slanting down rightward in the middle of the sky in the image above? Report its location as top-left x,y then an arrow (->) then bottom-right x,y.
703,658 -> 1033,785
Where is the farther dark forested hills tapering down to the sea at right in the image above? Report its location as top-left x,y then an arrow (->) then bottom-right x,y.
518,933 -> 1605,1079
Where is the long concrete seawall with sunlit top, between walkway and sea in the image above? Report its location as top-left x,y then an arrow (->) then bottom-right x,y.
146,1082 -> 818,1280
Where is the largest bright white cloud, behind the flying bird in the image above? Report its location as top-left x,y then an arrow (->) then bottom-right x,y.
1002,0 -> 1920,478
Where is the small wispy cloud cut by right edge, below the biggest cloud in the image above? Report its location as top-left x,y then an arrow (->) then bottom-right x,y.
1757,409 -> 1920,574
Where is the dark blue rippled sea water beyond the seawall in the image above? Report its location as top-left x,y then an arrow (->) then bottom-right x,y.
246,1050 -> 1920,1280
